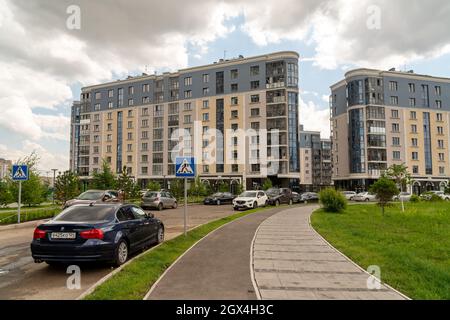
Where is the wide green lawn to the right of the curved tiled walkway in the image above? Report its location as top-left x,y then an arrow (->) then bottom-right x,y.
311,202 -> 450,299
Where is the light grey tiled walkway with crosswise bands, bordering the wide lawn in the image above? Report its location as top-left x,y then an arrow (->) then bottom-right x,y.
253,207 -> 405,300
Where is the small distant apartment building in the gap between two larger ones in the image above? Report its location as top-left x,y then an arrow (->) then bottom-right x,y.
299,125 -> 333,192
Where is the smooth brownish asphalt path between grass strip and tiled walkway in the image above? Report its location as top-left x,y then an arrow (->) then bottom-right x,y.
148,208 -> 283,300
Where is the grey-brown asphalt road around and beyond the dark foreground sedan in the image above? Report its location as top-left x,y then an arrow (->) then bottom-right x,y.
0,205 -> 239,300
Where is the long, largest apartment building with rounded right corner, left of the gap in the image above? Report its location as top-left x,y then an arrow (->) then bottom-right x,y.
70,52 -> 299,188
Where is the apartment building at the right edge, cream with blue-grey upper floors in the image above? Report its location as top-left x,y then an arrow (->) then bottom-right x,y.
330,69 -> 450,194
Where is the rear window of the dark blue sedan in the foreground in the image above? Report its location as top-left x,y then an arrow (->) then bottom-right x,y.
54,206 -> 115,222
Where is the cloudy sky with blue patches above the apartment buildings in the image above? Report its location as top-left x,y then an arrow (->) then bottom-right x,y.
0,0 -> 450,174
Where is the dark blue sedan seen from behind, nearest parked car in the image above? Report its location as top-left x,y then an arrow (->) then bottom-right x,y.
31,203 -> 164,266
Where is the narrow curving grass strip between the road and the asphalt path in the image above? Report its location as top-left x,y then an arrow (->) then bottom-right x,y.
85,208 -> 274,300
